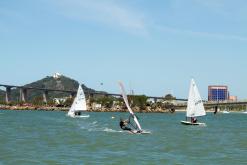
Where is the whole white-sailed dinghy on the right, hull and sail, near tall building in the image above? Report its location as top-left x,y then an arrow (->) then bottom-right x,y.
181,79 -> 206,125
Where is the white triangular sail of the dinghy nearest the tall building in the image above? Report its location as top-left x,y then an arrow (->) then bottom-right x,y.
186,79 -> 206,117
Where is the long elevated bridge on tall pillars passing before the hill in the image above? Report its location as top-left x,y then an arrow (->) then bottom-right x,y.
0,84 -> 187,103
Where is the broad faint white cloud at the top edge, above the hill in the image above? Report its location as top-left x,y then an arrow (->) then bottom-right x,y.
53,0 -> 147,35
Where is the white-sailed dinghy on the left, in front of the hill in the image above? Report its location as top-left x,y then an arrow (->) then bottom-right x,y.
68,85 -> 89,117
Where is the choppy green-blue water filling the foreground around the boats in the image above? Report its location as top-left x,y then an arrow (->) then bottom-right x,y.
0,111 -> 247,165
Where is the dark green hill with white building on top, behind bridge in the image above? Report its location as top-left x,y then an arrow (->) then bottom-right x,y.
0,75 -> 98,101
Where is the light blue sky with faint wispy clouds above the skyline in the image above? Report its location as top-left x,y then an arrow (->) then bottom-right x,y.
0,0 -> 247,99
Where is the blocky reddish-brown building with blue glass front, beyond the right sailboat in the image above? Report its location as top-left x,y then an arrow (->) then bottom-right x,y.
208,85 -> 229,101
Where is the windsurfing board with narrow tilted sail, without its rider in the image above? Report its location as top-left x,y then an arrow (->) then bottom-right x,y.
119,82 -> 151,134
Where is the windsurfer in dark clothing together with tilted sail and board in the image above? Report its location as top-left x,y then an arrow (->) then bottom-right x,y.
119,82 -> 151,134
